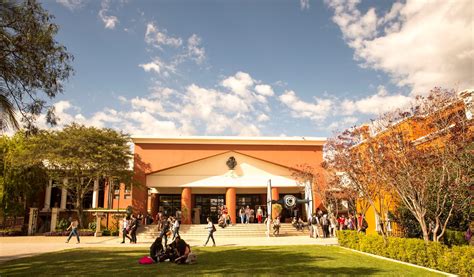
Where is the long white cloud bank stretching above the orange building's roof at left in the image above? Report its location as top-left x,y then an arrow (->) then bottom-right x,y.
42,71 -> 270,136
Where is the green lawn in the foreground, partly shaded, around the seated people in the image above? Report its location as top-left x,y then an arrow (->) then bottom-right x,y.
0,245 -> 444,277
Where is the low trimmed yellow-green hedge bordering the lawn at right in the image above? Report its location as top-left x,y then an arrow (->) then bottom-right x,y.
337,231 -> 474,276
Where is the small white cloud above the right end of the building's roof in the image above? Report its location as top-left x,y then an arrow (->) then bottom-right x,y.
279,90 -> 334,123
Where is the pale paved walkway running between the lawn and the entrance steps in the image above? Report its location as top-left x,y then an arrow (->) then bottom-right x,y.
0,235 -> 337,263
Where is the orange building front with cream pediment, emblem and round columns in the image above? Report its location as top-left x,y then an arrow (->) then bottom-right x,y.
132,137 -> 326,224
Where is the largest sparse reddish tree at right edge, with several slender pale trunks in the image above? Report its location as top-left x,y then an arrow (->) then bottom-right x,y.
374,88 -> 474,241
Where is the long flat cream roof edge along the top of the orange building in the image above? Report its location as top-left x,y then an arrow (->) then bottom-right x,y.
132,136 -> 326,146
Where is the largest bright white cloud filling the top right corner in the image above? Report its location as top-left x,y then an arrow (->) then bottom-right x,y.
325,0 -> 474,94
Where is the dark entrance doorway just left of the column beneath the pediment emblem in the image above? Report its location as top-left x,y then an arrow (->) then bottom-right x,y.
194,194 -> 225,224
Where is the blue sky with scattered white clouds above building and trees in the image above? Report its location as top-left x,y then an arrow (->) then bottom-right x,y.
39,0 -> 474,137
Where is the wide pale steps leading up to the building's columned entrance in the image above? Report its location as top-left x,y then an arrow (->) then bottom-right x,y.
137,223 -> 309,240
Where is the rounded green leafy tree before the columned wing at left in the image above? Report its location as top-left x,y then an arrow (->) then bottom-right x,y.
34,124 -> 132,224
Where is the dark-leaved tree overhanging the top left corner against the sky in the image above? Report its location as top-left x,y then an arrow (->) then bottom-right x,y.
0,0 -> 73,131
